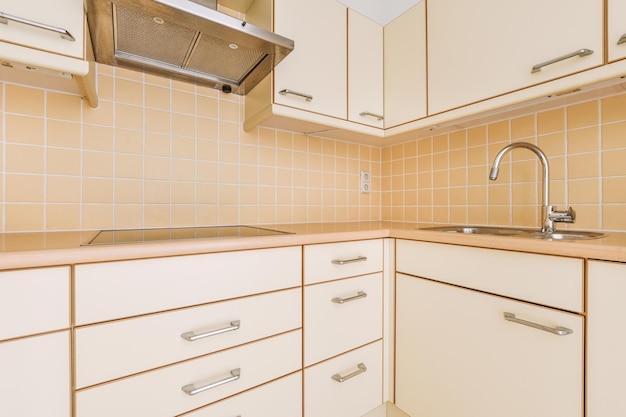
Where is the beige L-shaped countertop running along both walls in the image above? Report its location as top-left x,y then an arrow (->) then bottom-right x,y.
0,222 -> 626,269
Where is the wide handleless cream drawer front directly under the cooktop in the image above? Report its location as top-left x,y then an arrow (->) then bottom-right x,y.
75,246 -> 302,325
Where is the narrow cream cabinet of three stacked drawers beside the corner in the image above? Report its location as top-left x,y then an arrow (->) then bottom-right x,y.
304,239 -> 383,417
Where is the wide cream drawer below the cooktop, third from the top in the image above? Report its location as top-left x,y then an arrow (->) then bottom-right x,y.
76,330 -> 302,417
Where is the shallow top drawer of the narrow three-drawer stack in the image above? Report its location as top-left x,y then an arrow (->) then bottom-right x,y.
304,239 -> 383,284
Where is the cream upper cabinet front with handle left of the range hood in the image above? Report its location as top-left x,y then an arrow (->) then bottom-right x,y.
0,0 -> 84,58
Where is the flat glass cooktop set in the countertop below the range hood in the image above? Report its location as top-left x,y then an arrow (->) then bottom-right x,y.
84,226 -> 289,246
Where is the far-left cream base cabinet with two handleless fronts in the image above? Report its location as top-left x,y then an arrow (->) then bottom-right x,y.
0,267 -> 71,417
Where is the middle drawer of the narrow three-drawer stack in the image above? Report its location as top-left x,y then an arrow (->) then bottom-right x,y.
304,272 -> 383,366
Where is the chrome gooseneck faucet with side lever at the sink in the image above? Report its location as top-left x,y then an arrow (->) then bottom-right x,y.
489,142 -> 576,233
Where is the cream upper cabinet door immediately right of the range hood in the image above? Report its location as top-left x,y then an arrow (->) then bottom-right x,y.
274,0 -> 347,119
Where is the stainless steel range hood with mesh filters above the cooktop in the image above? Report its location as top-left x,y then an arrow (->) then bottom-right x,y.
87,0 -> 294,95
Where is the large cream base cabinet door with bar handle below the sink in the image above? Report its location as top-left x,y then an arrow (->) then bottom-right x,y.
396,274 -> 584,417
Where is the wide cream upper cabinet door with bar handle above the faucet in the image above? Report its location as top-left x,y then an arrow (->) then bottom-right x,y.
427,0 -> 603,114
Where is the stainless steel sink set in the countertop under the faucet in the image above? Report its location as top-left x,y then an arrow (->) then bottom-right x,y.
420,226 -> 605,240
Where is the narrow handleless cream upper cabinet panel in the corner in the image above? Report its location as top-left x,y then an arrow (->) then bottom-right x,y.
384,2 -> 426,128
